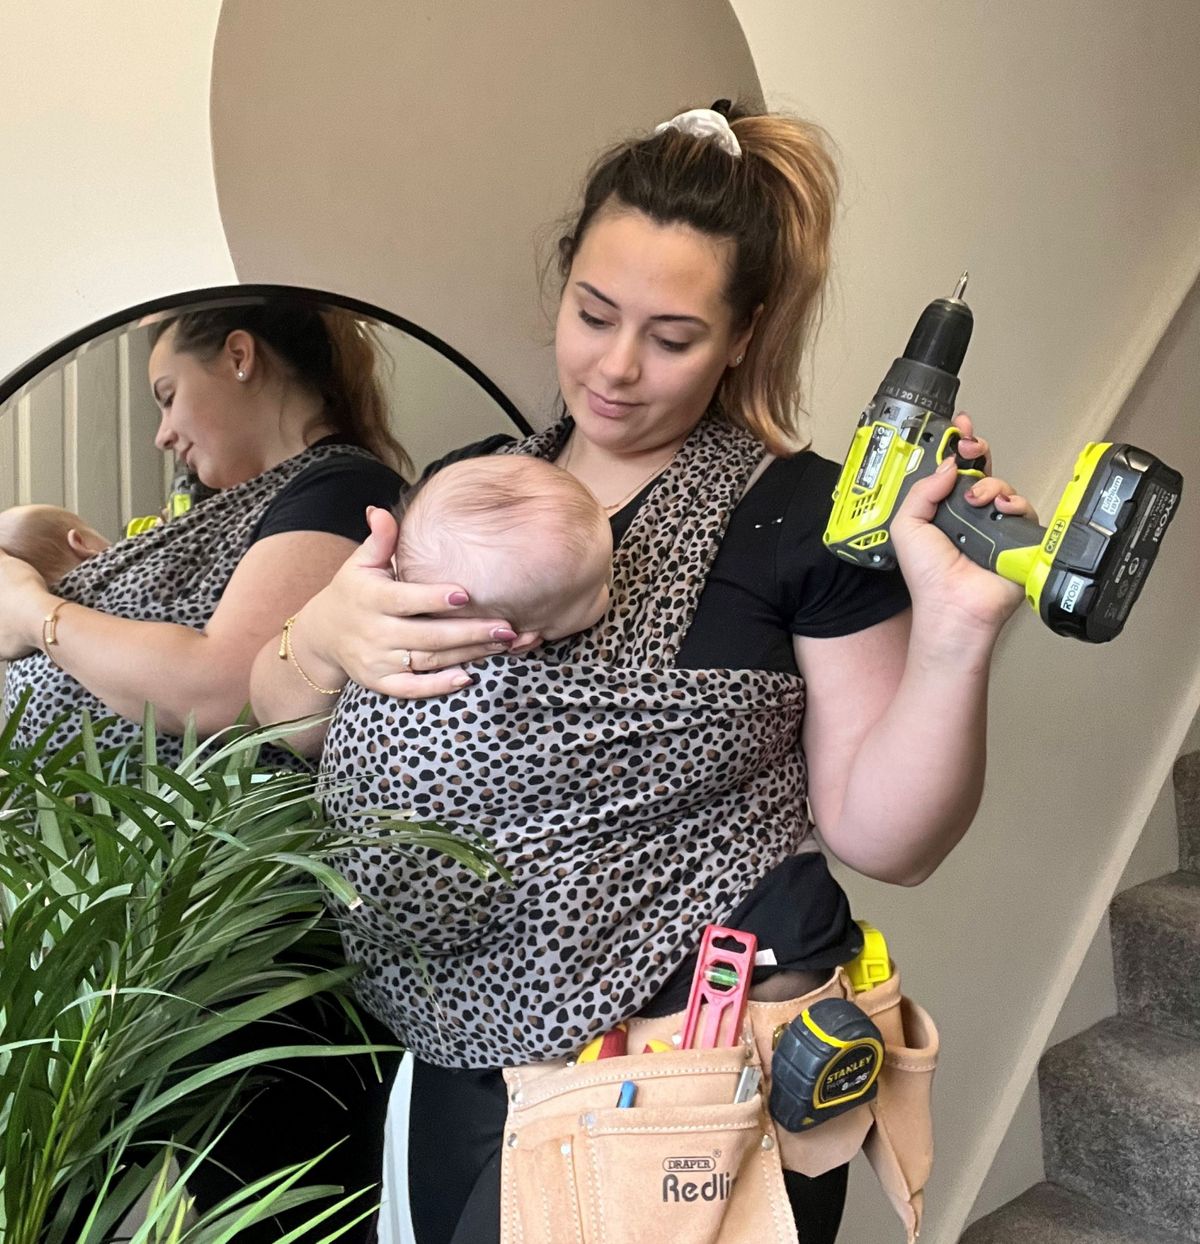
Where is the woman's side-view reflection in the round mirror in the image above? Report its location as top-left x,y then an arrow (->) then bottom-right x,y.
0,302 -> 407,1239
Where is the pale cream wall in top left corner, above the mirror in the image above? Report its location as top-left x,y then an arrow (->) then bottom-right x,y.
0,0 -> 234,377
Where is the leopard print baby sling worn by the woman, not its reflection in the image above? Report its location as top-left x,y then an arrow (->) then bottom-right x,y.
322,417 -> 816,1067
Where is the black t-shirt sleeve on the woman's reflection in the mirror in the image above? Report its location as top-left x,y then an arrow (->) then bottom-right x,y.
250,435 -> 404,544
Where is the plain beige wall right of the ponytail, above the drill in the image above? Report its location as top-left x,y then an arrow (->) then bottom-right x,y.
735,0 -> 1200,500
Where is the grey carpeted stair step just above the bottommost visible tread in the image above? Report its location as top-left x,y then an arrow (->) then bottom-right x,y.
1038,1015 -> 1200,1244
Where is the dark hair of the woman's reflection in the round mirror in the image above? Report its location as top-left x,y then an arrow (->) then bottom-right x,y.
150,300 -> 413,474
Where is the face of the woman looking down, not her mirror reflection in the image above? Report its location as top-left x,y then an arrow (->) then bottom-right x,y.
555,208 -> 750,454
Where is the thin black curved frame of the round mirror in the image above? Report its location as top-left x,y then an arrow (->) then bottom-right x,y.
0,285 -> 533,435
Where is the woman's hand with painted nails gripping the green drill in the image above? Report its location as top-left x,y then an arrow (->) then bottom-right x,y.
892,413 -> 1037,641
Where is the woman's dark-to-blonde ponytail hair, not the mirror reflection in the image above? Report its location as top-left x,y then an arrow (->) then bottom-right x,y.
558,100 -> 838,454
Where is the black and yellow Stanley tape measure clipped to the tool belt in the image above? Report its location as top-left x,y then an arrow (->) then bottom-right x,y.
770,998 -> 883,1132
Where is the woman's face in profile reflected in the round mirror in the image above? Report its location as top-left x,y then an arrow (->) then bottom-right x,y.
149,328 -> 262,488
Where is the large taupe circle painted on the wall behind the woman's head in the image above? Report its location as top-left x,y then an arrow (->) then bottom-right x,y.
211,0 -> 761,427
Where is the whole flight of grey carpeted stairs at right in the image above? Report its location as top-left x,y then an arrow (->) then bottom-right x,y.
960,753 -> 1200,1244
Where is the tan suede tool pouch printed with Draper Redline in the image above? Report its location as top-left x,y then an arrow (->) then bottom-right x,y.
500,1045 -> 796,1244
